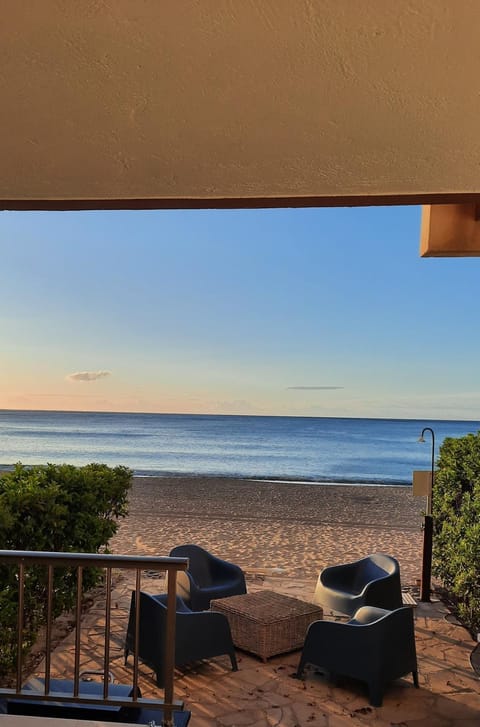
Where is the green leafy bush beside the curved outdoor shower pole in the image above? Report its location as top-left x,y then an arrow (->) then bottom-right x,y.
433,432 -> 480,634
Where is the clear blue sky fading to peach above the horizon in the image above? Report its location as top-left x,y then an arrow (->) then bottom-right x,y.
0,207 -> 480,420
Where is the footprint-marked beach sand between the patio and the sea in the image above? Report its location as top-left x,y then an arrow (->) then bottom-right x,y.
110,476 -> 425,586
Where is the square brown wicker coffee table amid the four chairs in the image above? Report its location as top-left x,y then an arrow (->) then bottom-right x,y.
210,591 -> 323,661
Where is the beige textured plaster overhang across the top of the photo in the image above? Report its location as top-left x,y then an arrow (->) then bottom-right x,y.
0,0 -> 480,201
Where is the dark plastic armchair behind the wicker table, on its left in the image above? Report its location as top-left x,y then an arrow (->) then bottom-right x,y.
170,545 -> 247,611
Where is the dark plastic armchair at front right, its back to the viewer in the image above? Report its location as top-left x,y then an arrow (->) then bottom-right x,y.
297,606 -> 418,707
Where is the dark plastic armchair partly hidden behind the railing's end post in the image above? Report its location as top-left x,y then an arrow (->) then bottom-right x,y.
125,591 -> 238,687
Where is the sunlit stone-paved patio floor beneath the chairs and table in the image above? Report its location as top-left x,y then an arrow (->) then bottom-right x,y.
31,576 -> 480,727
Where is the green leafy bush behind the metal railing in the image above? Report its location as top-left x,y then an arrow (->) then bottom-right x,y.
0,464 -> 132,672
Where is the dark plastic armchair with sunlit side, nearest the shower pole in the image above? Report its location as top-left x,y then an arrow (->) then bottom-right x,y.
313,553 -> 402,616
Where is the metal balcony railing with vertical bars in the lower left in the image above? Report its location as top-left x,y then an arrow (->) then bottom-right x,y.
0,550 -> 188,727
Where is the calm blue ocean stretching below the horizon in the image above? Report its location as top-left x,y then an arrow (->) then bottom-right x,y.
0,410 -> 480,485
